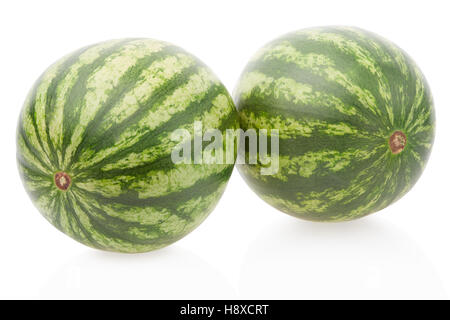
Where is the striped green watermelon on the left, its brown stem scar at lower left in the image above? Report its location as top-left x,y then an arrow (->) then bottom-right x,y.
17,39 -> 238,253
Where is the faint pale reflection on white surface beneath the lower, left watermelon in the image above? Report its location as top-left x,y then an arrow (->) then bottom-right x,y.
40,245 -> 235,299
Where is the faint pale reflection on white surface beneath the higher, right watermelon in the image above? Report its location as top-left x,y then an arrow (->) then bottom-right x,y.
239,217 -> 446,299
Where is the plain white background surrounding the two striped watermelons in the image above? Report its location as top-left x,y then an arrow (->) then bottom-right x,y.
0,0 -> 450,299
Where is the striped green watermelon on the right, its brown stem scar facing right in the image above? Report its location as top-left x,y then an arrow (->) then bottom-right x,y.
235,27 -> 435,221
